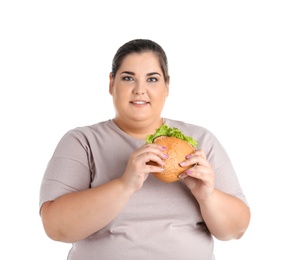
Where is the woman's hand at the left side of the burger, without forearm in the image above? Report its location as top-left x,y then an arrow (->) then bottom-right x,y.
121,144 -> 167,191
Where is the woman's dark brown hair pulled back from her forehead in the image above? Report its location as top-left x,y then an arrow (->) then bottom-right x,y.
111,39 -> 169,82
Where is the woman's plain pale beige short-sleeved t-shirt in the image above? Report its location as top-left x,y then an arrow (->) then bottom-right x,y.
39,119 -> 246,260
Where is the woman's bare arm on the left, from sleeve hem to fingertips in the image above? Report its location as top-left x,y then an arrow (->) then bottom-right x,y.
41,144 -> 166,242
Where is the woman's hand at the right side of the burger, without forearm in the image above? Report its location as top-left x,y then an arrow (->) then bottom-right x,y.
180,150 -> 214,201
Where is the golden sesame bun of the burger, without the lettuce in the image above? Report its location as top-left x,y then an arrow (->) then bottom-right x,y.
147,136 -> 195,182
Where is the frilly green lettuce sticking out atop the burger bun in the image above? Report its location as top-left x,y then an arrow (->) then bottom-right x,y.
146,124 -> 198,148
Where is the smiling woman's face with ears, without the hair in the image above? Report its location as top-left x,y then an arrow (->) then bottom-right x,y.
109,52 -> 169,126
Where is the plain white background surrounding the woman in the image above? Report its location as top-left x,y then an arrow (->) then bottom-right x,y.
0,0 -> 288,260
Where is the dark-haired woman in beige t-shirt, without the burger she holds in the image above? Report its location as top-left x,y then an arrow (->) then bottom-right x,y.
40,39 -> 250,260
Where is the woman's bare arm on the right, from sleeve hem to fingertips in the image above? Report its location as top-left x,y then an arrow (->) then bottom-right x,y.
180,150 -> 250,240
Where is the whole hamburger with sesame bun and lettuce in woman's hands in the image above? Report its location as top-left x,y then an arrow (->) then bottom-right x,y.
146,124 -> 198,182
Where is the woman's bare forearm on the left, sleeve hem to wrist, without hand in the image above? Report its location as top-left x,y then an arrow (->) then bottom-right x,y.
41,179 -> 133,242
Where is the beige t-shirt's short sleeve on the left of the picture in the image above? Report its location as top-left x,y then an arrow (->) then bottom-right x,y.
39,130 -> 91,208
